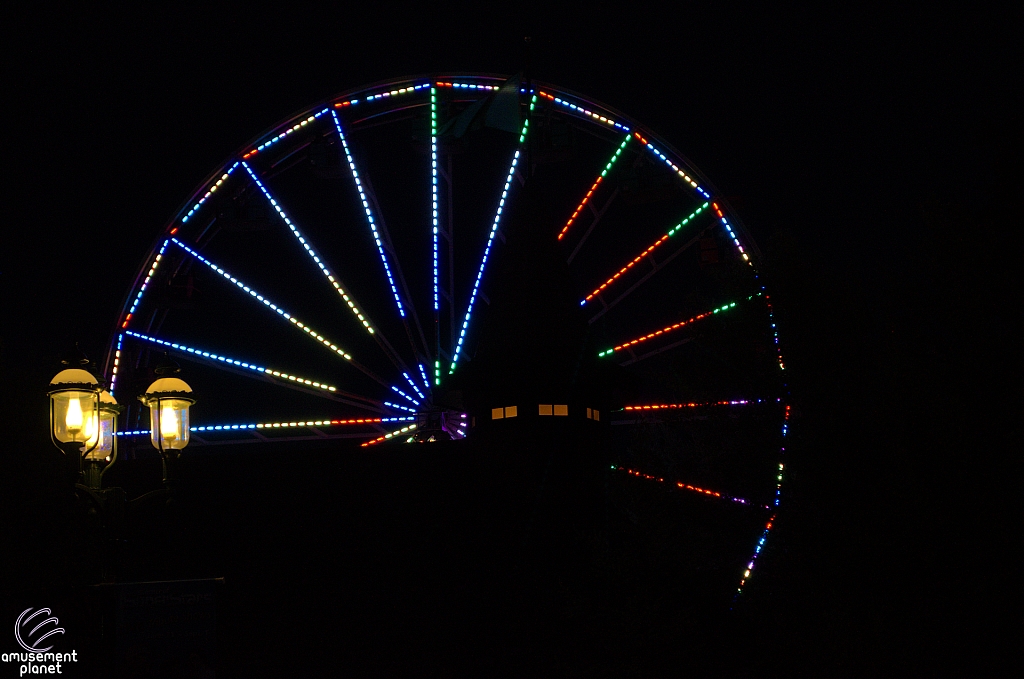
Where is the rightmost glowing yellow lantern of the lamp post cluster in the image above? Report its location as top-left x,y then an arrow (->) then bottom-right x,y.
139,358 -> 196,487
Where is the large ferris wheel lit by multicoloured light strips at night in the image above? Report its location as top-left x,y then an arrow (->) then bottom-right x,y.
104,74 -> 790,591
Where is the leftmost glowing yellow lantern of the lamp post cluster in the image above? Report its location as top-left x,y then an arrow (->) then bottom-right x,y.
47,368 -> 100,456
